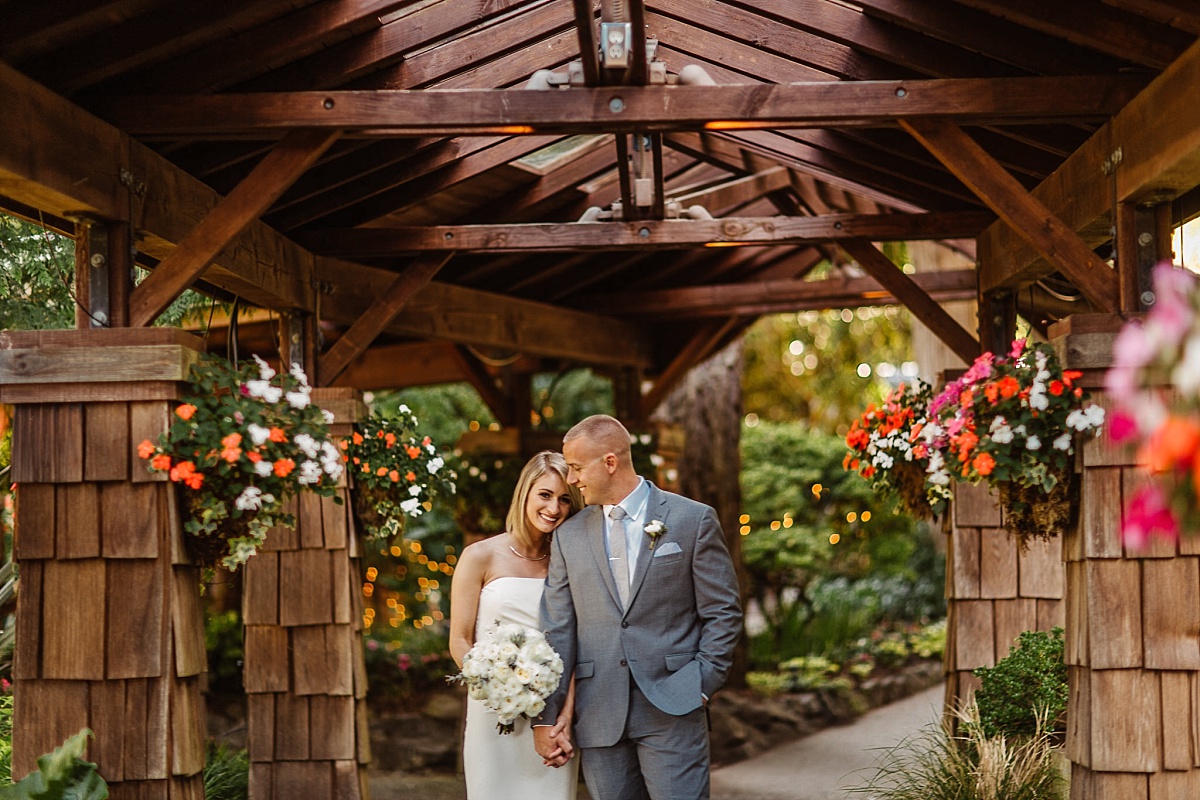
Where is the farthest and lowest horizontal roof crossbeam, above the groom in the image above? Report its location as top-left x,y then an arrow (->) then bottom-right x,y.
588,268 -> 976,319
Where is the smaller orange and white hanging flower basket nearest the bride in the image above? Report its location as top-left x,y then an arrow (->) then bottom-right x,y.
337,405 -> 456,539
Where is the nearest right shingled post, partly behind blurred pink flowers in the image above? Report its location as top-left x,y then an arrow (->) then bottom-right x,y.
1051,314 -> 1200,800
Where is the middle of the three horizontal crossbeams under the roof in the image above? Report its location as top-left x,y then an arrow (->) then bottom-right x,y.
296,211 -> 994,258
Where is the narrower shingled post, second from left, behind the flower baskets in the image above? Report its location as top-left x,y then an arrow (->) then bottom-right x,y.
235,389 -> 371,800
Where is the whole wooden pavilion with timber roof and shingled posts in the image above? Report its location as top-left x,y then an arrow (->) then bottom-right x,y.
0,0 -> 1200,800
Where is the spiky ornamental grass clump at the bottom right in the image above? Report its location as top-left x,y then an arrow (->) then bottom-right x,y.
851,705 -> 1064,800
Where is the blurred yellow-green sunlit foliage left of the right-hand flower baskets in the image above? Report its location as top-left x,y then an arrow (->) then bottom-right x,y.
742,299 -> 912,433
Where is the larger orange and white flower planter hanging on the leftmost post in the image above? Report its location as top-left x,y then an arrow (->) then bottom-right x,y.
138,356 -> 343,571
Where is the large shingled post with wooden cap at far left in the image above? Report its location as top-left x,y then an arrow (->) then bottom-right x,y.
0,329 -> 205,800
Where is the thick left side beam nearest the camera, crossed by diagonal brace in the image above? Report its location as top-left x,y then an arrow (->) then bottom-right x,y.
0,62 -> 313,308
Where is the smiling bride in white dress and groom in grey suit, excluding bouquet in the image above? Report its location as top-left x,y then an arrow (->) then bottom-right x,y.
450,415 -> 742,800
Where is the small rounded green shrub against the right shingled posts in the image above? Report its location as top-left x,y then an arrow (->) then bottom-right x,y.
974,627 -> 1067,736
